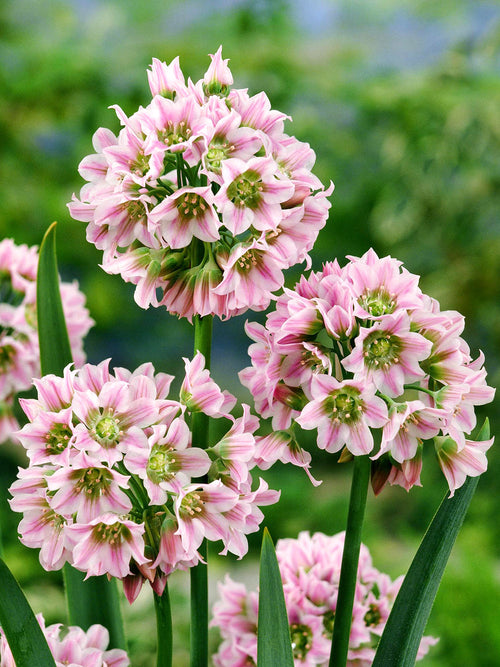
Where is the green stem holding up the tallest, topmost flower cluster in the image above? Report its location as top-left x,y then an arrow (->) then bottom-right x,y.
190,316 -> 212,667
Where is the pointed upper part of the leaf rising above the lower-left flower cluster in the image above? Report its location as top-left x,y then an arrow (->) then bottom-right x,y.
36,222 -> 72,376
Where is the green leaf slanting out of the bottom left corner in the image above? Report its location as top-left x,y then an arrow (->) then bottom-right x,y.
0,558 -> 56,667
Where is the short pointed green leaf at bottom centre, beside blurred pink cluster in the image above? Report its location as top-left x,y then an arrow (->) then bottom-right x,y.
257,528 -> 293,667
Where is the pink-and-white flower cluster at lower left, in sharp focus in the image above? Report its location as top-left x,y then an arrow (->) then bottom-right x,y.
10,353 -> 279,601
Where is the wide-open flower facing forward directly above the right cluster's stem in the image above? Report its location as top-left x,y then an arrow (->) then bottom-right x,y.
296,375 -> 388,456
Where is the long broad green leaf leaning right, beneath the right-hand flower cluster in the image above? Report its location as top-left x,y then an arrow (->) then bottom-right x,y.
373,420 -> 490,667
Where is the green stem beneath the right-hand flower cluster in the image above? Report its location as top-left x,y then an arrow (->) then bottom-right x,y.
329,456 -> 371,667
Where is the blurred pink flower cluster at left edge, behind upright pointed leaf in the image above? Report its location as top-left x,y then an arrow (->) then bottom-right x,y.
0,239 -> 94,443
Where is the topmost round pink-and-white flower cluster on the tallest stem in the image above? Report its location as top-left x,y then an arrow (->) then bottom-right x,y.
68,48 -> 333,319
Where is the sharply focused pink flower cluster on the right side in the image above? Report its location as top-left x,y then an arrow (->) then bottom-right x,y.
240,250 -> 494,494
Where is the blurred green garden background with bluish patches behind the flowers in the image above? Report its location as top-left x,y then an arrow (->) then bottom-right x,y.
0,0 -> 500,667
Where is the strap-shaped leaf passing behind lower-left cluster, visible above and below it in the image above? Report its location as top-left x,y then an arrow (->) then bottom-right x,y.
36,222 -> 126,648
